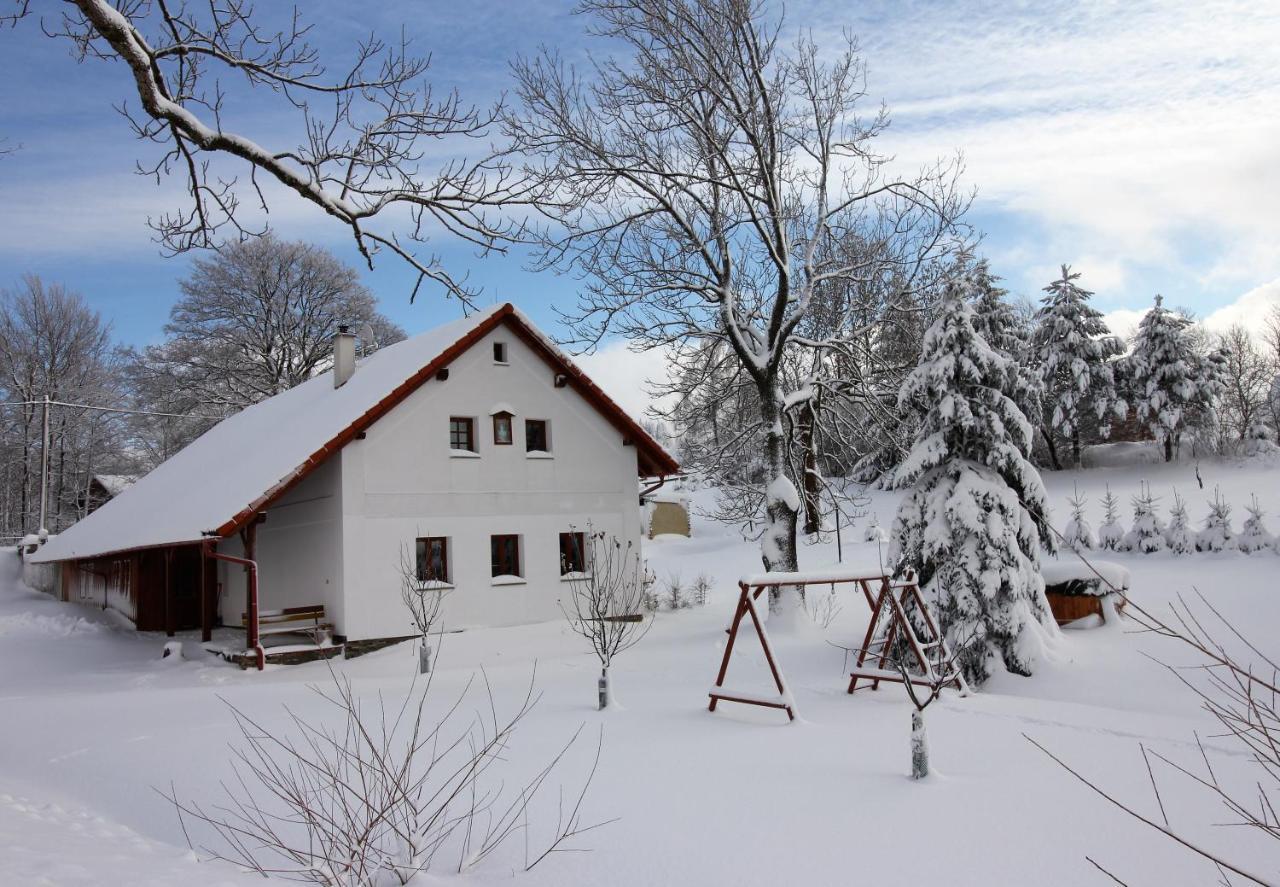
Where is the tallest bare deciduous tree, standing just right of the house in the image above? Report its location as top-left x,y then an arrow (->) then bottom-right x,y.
506,0 -> 964,609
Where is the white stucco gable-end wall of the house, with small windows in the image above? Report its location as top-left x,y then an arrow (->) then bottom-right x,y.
335,326 -> 641,640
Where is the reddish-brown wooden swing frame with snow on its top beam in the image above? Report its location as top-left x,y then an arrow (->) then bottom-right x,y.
707,568 -> 970,721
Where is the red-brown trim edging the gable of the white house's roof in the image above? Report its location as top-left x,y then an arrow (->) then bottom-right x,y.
216,302 -> 680,538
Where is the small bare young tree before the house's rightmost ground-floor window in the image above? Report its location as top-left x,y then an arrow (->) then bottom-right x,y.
561,531 -> 653,710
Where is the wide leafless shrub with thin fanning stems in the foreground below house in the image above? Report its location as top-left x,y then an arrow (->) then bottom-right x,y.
166,676 -> 603,887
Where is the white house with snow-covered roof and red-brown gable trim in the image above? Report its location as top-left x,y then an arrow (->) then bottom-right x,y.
31,305 -> 677,646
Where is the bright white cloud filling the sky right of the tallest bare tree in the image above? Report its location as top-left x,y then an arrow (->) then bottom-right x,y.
824,0 -> 1280,304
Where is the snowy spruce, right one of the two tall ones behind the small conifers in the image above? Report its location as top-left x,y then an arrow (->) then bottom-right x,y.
1125,296 -> 1217,462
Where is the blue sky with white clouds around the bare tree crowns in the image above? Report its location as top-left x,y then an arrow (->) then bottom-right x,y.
0,0 -> 1280,391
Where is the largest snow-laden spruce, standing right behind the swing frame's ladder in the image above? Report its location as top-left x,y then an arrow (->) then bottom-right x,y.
890,283 -> 1056,683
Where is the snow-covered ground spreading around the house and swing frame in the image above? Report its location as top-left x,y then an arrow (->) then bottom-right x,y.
0,453 -> 1280,887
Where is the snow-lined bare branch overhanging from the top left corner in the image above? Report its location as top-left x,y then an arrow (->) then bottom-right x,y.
4,0 -> 527,303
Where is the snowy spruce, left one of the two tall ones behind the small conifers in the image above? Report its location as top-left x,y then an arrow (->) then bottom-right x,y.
1032,265 -> 1125,468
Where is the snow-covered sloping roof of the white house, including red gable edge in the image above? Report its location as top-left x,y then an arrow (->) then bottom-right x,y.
32,303 -> 677,561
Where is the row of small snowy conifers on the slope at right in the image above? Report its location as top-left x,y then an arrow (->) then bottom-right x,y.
1062,483 -> 1280,554
